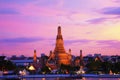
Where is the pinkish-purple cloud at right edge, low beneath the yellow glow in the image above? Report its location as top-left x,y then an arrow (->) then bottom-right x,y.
96,40 -> 120,49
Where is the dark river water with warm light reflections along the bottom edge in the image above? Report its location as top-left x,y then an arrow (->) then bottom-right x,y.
22,78 -> 120,80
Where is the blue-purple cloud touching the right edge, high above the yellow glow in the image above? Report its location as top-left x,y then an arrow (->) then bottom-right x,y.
102,7 -> 120,15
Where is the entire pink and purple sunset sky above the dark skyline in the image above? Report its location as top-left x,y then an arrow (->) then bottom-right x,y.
0,0 -> 120,56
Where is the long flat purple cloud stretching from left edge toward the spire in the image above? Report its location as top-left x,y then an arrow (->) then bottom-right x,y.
0,37 -> 43,43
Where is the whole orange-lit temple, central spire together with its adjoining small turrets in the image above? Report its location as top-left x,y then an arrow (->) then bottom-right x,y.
48,26 -> 71,66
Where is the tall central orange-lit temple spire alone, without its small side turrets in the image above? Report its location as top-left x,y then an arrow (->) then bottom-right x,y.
54,26 -> 70,65
